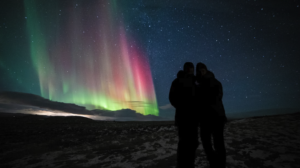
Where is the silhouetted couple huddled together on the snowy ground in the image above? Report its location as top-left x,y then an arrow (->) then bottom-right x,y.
169,62 -> 227,168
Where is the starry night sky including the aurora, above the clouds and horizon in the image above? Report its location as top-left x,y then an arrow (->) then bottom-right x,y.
0,0 -> 300,115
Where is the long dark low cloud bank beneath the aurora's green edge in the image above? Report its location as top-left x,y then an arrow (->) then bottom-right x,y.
0,92 -> 164,121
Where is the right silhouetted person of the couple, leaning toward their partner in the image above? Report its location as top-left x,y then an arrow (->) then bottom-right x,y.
196,62 -> 227,168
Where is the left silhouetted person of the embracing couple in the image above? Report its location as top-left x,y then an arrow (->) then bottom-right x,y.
169,62 -> 199,168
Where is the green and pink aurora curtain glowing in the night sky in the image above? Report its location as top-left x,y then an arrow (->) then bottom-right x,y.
25,0 -> 158,116
